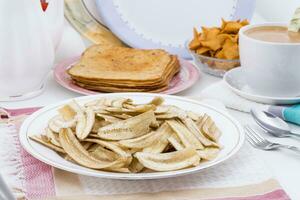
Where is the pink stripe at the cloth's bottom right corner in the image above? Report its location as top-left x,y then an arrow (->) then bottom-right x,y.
210,189 -> 290,200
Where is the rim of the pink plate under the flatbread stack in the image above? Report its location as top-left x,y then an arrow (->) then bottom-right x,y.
53,56 -> 200,95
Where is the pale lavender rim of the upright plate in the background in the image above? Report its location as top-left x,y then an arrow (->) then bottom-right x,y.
96,0 -> 255,59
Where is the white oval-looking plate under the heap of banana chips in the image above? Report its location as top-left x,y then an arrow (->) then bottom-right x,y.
20,93 -> 244,180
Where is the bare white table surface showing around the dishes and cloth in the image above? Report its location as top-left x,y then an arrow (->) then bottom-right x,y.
0,70 -> 300,199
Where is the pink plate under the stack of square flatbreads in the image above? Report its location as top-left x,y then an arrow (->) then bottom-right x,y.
54,56 -> 200,95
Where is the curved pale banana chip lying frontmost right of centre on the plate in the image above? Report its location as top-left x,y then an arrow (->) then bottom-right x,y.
134,148 -> 200,171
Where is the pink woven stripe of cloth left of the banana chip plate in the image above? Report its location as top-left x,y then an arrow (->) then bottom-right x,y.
14,108 -> 55,199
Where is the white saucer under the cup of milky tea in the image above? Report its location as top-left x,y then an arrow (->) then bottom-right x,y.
223,67 -> 300,104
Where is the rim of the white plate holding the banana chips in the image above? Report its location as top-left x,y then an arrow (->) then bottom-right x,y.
19,93 -> 245,180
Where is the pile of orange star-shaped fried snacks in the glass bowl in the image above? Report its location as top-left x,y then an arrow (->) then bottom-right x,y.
189,19 -> 249,60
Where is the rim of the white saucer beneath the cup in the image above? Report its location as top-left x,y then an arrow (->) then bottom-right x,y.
223,66 -> 300,104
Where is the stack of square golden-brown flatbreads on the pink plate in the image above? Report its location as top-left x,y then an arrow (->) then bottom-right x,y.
68,45 -> 180,92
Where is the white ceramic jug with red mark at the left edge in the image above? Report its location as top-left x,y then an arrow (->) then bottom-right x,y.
0,0 -> 63,101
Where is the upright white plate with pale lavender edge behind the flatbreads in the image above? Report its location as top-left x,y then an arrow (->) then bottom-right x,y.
96,0 -> 255,58
